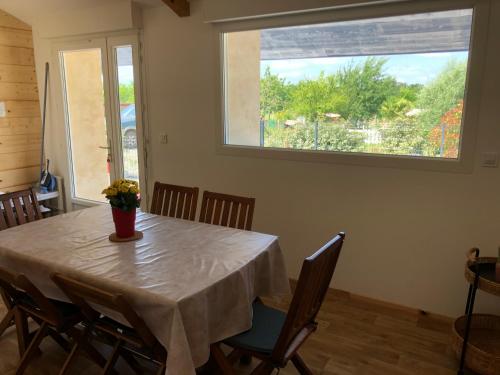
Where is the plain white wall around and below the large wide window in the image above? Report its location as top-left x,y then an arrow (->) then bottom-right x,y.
139,1 -> 500,315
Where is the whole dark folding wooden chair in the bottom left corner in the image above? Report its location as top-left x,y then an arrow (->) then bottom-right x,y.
0,268 -> 87,375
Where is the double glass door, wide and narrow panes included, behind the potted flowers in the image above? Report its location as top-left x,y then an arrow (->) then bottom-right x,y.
58,35 -> 146,203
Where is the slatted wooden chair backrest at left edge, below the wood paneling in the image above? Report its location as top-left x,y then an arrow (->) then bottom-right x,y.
0,188 -> 42,230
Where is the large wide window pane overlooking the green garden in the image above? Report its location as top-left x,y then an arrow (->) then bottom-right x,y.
225,9 -> 473,159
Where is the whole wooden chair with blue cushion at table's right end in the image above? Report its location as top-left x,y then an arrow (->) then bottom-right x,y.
211,233 -> 345,375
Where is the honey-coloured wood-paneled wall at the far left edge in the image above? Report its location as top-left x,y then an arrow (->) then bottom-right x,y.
0,10 -> 41,192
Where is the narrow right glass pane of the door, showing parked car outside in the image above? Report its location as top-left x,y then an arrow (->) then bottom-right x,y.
115,46 -> 139,182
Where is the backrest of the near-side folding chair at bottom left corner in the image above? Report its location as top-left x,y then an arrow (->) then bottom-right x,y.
0,267 -> 62,326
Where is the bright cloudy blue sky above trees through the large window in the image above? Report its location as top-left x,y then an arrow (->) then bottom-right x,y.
260,52 -> 468,85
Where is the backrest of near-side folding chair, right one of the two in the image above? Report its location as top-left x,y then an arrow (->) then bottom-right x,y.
51,273 -> 159,347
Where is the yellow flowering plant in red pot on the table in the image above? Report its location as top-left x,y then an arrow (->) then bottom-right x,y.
102,179 -> 141,238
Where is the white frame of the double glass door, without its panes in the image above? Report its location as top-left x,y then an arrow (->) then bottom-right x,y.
51,29 -> 149,211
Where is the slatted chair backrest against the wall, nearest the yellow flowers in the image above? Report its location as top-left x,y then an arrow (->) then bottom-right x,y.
150,182 -> 199,220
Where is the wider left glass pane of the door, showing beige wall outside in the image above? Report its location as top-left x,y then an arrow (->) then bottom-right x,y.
60,49 -> 110,201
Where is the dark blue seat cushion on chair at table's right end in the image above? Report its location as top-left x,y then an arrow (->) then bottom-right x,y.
224,302 -> 286,354
